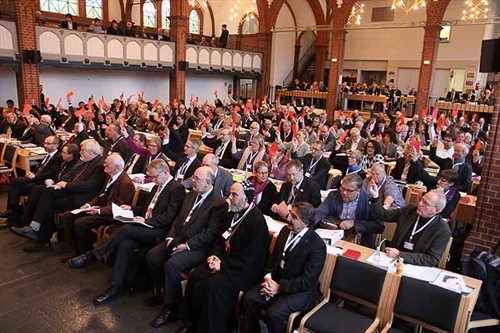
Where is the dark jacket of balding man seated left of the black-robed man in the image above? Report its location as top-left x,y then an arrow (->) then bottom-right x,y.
167,190 -> 227,251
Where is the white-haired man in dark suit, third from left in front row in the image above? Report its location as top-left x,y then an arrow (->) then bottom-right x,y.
10,139 -> 106,252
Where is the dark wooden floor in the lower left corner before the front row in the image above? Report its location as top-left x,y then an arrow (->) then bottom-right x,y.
0,188 -> 180,333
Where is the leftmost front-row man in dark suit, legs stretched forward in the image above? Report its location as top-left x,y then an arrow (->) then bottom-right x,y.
0,136 -> 62,220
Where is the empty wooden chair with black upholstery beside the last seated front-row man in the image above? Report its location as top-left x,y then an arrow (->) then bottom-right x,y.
298,256 -> 392,333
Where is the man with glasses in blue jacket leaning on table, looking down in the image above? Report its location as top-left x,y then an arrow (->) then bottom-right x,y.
316,174 -> 384,248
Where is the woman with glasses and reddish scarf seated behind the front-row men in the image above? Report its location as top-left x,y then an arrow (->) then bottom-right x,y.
248,161 -> 278,215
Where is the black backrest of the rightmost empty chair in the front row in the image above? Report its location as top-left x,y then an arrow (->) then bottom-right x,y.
394,276 -> 462,332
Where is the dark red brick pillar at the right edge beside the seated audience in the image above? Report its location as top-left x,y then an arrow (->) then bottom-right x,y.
463,82 -> 500,254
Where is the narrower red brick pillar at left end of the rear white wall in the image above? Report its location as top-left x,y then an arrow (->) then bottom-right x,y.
326,27 -> 347,120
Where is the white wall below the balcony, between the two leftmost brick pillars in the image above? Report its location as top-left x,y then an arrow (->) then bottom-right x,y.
38,66 -> 169,102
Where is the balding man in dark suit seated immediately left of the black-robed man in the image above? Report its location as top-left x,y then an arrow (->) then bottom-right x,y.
147,167 -> 227,327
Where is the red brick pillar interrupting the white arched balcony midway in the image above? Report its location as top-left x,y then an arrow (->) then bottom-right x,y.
170,0 -> 189,101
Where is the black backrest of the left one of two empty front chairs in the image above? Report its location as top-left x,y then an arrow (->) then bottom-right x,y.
330,256 -> 387,307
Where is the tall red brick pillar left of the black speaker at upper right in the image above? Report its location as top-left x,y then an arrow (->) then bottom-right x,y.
415,0 -> 450,114
